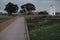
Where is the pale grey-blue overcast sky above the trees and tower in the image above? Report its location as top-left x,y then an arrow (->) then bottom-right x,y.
0,0 -> 60,12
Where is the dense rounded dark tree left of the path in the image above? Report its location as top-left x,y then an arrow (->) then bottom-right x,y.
4,2 -> 18,15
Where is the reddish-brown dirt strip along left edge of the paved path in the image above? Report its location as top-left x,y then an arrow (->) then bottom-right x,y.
0,16 -> 18,32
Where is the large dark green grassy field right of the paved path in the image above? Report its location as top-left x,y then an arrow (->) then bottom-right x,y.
26,16 -> 60,40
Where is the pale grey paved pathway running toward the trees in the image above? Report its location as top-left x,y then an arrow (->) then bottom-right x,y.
0,17 -> 25,40
